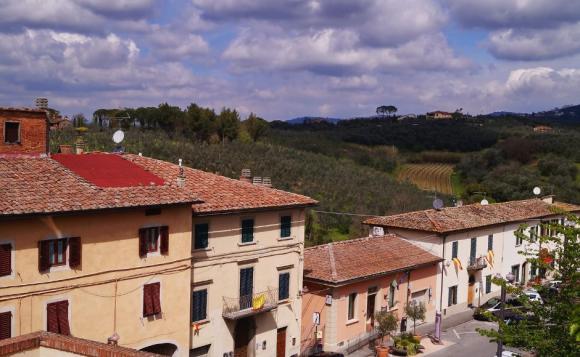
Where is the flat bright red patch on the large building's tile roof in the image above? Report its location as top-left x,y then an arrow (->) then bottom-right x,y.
52,153 -> 164,187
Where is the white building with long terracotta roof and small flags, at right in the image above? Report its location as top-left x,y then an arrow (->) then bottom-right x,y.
365,197 -> 580,315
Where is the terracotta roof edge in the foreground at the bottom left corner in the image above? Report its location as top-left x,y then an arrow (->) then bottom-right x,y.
0,331 -> 161,357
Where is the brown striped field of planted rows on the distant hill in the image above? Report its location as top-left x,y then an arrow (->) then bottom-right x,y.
397,164 -> 453,195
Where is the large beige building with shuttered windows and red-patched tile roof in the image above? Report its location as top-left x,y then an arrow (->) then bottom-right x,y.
0,110 -> 316,357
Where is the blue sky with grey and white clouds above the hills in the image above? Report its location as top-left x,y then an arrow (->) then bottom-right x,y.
0,0 -> 580,120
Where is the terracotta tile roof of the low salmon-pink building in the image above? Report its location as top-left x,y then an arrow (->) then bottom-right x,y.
304,234 -> 442,285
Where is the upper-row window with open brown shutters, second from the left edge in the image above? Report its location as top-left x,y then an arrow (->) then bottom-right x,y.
38,237 -> 81,271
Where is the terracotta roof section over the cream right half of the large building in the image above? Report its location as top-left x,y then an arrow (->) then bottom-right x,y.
124,154 -> 318,214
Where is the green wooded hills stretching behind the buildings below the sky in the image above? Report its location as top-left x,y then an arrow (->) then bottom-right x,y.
57,103 -> 580,244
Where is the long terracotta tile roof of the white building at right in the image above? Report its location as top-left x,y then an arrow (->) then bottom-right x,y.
364,198 -> 580,233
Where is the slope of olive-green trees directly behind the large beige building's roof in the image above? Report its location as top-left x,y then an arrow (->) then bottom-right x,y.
51,129 -> 431,243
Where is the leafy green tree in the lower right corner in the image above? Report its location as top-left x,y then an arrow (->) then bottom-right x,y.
478,210 -> 580,356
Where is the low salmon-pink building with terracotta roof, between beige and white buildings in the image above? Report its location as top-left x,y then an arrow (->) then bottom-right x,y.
301,234 -> 441,354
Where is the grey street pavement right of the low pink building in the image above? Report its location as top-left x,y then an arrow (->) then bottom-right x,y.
428,320 -> 497,357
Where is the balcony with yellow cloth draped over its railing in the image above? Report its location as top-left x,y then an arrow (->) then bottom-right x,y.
222,289 -> 278,320
